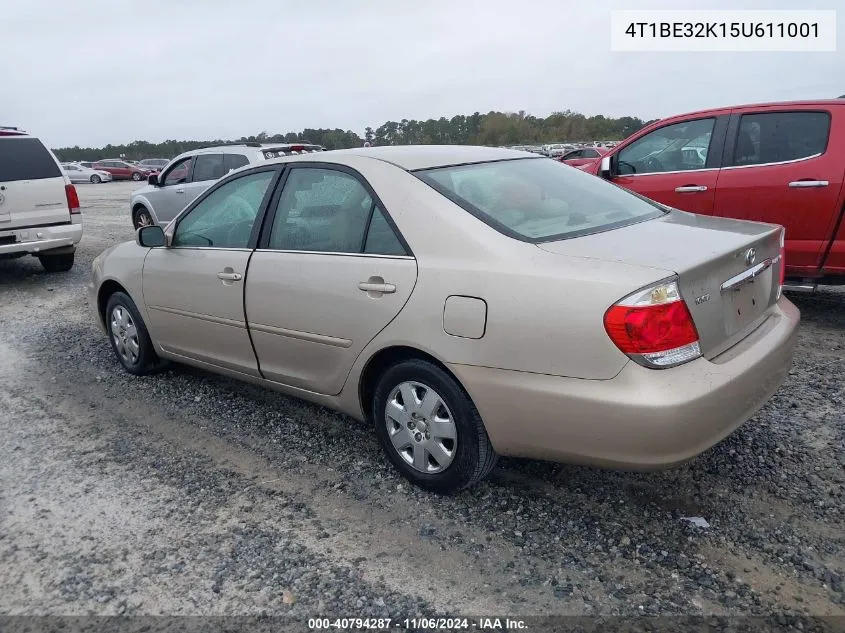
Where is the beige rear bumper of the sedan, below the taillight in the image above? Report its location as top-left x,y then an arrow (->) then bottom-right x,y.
450,298 -> 800,469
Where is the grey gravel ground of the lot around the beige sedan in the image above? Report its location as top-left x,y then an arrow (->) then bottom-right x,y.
0,183 -> 845,630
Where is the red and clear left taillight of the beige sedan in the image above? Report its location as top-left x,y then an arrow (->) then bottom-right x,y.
604,280 -> 701,369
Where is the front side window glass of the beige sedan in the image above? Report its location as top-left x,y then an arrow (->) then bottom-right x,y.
171,171 -> 275,248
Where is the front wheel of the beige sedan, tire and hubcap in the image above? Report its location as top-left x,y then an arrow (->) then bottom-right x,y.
104,292 -> 163,376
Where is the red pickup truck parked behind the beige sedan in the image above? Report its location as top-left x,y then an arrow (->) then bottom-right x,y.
577,99 -> 845,289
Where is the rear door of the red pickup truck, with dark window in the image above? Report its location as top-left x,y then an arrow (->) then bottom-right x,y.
715,106 -> 845,275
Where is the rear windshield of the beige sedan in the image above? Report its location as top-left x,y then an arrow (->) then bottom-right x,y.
415,158 -> 666,242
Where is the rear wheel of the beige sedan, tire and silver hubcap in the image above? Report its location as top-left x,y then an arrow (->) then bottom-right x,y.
372,359 -> 497,495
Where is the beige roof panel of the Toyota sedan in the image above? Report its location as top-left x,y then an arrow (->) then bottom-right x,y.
275,145 -> 543,171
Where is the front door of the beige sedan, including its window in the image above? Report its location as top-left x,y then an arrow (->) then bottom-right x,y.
142,167 -> 278,376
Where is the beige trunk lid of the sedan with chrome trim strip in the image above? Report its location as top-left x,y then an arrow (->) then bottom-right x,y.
538,210 -> 783,358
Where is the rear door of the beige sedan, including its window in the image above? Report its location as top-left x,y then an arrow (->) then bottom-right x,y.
245,163 -> 417,394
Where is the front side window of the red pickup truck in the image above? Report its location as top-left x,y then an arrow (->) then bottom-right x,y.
618,119 -> 716,175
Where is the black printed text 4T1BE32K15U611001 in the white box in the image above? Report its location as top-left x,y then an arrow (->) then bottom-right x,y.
625,22 -> 819,38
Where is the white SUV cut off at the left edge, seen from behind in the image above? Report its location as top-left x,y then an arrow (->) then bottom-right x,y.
0,127 -> 82,272
